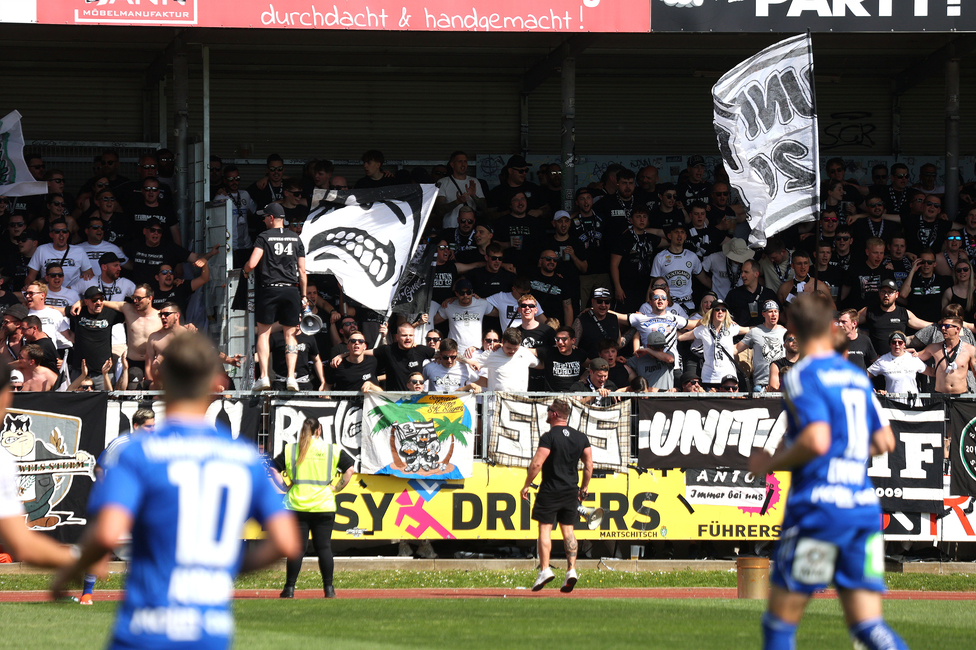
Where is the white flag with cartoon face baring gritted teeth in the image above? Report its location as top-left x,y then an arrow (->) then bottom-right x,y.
302,185 -> 437,312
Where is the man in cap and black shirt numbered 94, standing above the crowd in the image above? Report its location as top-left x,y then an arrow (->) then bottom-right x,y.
244,203 -> 308,391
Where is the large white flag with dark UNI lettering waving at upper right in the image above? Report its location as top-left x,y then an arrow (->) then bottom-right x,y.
712,34 -> 820,246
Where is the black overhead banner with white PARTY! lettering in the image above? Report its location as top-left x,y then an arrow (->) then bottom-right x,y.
651,0 -> 964,34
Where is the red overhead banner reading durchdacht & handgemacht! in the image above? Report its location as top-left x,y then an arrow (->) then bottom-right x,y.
36,0 -> 651,32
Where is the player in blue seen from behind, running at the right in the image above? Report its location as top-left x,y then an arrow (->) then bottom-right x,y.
750,294 -> 908,650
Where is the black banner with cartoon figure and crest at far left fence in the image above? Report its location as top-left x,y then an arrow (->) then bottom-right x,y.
0,393 -> 108,543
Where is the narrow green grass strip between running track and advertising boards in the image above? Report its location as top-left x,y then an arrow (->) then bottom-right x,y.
0,565 -> 976,591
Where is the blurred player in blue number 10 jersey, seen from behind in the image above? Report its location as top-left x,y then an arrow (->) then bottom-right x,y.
52,333 -> 304,649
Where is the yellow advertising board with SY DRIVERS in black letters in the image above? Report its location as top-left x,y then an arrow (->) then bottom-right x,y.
248,462 -> 789,541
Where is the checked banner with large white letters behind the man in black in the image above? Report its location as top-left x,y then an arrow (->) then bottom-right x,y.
488,393 -> 630,472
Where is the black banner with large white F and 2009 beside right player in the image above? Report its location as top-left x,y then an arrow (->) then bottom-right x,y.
868,400 -> 945,512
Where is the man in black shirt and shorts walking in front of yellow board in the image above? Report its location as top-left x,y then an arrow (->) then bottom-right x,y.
522,399 -> 593,593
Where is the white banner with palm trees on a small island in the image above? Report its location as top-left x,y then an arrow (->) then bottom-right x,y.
360,393 -> 475,480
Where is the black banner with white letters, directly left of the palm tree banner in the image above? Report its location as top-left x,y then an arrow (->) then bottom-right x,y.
267,397 -> 363,460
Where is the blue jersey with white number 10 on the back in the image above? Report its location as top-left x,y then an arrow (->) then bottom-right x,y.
89,418 -> 283,649
